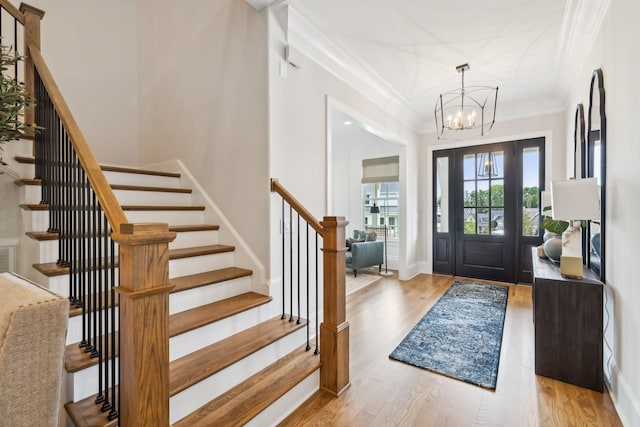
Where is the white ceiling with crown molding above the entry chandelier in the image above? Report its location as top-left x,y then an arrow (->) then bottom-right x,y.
247,0 -> 610,132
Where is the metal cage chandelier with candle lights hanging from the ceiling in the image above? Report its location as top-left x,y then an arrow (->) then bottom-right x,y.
434,64 -> 498,139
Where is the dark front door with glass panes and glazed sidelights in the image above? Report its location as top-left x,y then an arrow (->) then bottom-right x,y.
433,138 -> 544,283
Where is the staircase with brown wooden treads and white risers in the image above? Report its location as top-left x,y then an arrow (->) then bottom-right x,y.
16,157 -> 320,426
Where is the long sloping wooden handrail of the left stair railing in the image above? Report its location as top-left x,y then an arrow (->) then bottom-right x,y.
28,43 -> 128,233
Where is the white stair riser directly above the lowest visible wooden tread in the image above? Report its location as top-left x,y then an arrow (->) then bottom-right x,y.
169,328 -> 310,423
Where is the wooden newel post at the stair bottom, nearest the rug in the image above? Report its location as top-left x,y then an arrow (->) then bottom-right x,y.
320,216 -> 350,396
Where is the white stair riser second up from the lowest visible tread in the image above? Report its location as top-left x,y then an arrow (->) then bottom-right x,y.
169,304 -> 273,361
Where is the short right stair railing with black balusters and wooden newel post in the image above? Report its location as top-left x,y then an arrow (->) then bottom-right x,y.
271,179 -> 350,396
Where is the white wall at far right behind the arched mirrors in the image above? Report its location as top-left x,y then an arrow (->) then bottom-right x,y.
566,0 -> 640,426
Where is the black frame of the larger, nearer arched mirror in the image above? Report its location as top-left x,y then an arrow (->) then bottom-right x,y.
585,68 -> 607,282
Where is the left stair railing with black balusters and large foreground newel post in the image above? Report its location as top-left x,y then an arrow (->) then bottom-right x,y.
0,0 -> 175,427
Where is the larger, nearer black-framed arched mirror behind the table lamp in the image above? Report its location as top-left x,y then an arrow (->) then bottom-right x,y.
585,68 -> 607,282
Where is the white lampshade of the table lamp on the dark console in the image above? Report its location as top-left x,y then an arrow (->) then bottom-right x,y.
551,178 -> 600,221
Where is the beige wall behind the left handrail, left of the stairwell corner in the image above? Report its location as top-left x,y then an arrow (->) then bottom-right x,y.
29,0 -> 138,165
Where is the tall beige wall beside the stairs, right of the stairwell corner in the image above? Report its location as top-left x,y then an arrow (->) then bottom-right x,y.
138,0 -> 269,272
